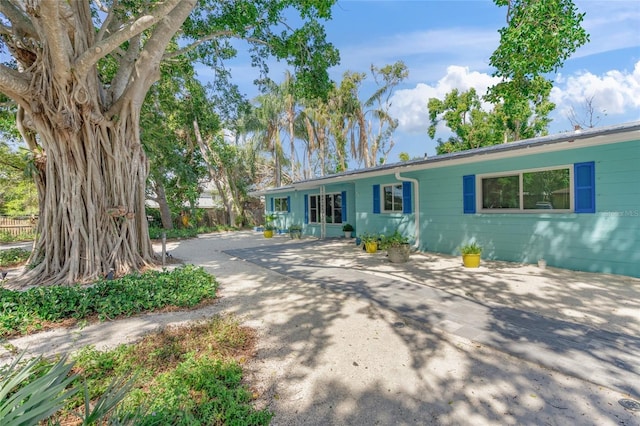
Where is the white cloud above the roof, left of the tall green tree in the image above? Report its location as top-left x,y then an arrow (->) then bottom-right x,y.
391,65 -> 499,133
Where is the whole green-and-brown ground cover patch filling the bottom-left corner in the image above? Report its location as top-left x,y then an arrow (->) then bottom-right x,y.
0,316 -> 272,426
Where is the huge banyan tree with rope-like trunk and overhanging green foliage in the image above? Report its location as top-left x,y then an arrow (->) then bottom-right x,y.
0,0 -> 338,284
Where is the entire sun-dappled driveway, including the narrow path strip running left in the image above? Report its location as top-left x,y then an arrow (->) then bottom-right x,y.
0,232 -> 640,425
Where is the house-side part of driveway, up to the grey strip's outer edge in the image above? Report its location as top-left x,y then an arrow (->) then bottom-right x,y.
227,240 -> 640,395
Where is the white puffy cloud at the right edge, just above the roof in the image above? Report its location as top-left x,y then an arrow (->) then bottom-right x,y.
551,61 -> 640,120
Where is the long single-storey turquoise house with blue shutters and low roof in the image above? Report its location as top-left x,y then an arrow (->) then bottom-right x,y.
255,122 -> 640,277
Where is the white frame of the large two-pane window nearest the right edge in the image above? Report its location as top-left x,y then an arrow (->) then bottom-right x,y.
476,164 -> 575,214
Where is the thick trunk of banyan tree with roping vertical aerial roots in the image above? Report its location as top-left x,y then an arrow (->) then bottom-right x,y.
22,102 -> 154,284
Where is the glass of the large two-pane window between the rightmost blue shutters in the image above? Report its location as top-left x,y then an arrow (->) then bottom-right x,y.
480,167 -> 573,211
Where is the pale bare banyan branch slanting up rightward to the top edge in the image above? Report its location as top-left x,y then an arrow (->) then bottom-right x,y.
76,0 -> 185,76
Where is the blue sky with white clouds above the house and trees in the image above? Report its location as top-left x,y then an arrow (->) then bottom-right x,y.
212,0 -> 640,162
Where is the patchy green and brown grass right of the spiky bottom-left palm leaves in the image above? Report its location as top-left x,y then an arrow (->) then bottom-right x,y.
71,316 -> 271,425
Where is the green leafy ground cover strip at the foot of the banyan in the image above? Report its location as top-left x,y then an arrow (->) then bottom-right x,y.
0,265 -> 218,338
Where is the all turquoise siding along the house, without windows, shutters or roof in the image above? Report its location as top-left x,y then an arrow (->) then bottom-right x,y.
267,136 -> 640,277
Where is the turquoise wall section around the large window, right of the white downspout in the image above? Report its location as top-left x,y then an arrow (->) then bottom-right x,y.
420,141 -> 640,276
